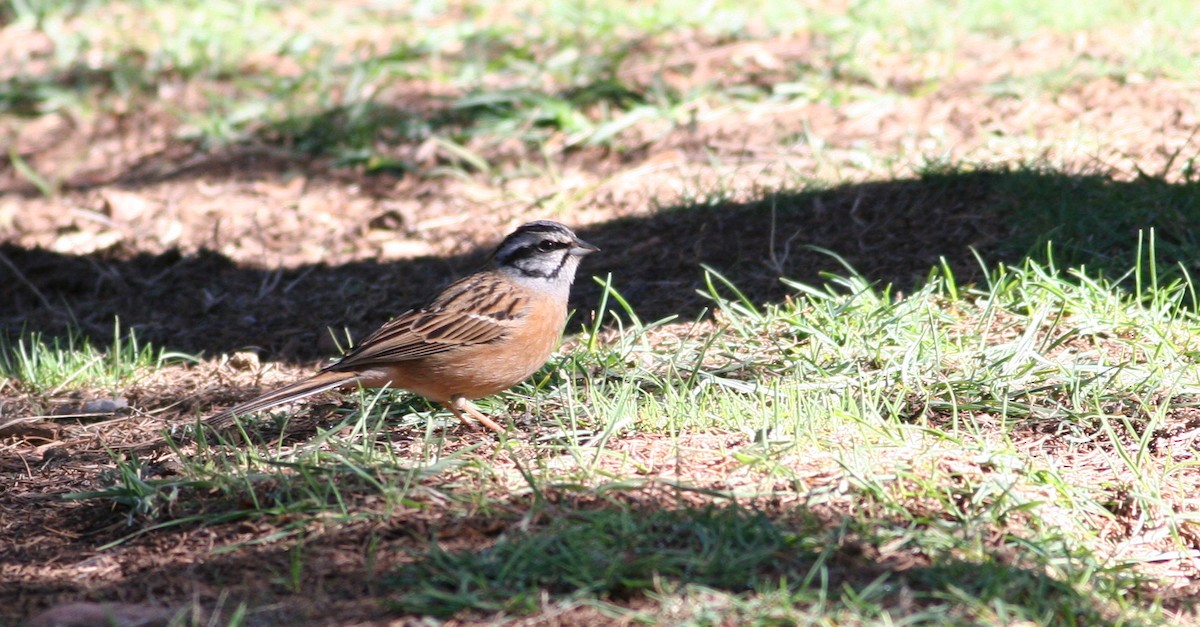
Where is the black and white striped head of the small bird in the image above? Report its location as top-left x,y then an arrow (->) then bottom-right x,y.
492,220 -> 600,292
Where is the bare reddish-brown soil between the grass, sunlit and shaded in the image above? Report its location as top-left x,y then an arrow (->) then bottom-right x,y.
0,23 -> 1200,625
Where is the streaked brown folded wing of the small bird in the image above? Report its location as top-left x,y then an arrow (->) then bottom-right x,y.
325,274 -> 524,371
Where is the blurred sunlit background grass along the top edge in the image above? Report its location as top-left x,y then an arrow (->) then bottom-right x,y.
9,0 -> 1200,172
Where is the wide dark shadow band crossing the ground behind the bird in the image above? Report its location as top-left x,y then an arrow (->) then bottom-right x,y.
0,169 -> 1200,360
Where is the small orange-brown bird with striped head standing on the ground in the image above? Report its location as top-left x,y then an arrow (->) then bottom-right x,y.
204,220 -> 600,432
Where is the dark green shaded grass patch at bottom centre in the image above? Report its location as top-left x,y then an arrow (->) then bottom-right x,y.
386,508 -> 817,616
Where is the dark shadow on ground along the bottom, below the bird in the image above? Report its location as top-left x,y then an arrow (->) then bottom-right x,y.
0,491 -> 1134,625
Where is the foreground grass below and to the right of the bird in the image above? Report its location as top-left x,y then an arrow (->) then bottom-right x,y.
32,237 -> 1200,625
